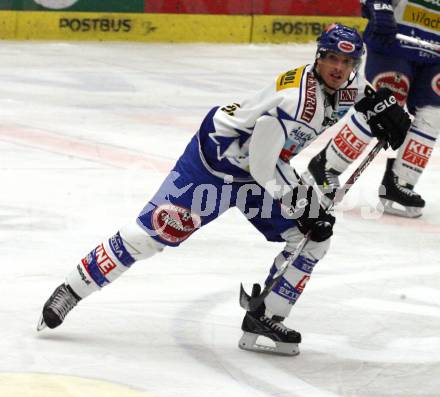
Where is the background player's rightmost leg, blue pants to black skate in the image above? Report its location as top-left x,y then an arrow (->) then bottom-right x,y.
379,65 -> 440,218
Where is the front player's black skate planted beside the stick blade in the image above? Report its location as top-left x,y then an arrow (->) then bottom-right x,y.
238,284 -> 301,356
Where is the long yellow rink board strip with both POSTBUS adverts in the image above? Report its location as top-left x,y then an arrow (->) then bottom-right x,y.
0,11 -> 365,44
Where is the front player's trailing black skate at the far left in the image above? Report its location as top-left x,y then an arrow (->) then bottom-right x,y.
37,284 -> 81,331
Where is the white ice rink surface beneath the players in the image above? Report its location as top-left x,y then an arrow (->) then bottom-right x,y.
0,41 -> 440,397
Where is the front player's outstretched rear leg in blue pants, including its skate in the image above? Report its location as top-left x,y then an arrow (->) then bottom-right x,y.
38,135 -> 233,330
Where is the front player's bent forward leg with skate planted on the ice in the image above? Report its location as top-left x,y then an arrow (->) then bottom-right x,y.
237,193 -> 330,355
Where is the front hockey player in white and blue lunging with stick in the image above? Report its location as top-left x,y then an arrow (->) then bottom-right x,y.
38,25 -> 410,355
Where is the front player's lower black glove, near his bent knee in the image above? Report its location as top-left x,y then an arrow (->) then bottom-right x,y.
282,185 -> 336,242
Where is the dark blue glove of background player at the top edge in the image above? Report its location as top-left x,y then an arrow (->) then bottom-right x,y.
363,0 -> 397,46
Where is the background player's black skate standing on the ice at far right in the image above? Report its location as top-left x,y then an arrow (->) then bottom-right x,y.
379,159 -> 425,218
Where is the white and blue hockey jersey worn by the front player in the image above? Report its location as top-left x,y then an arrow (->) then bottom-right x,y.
198,65 -> 368,197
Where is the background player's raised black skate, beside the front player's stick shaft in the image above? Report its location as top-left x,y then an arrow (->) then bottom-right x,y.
303,145 -> 341,200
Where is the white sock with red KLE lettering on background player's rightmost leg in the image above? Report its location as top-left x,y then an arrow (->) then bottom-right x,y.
393,106 -> 440,186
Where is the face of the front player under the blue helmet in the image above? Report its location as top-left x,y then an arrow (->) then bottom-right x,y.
317,51 -> 356,90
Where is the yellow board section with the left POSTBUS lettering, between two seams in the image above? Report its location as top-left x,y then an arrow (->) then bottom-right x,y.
16,12 -> 252,43
